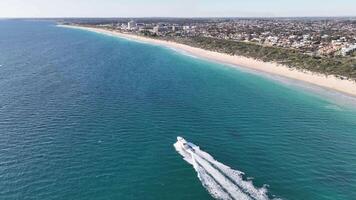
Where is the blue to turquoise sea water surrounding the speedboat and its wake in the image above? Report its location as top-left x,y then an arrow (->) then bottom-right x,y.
0,20 -> 356,200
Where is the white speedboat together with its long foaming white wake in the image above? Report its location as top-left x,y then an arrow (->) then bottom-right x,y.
174,137 -> 276,200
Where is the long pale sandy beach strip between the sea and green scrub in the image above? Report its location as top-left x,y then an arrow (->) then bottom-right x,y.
58,25 -> 356,97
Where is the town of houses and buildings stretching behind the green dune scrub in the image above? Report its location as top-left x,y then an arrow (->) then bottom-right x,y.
82,18 -> 356,57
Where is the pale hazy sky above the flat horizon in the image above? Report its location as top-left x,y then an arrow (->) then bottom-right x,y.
0,0 -> 356,18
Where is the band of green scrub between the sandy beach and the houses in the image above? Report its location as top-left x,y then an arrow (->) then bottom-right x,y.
165,37 -> 356,80
